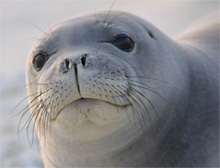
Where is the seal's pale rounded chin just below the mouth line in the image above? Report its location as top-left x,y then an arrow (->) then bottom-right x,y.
51,98 -> 132,142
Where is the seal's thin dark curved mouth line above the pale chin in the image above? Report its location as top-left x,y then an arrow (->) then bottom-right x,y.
51,97 -> 132,121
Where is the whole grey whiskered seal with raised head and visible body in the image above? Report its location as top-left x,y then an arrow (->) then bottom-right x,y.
26,11 -> 219,167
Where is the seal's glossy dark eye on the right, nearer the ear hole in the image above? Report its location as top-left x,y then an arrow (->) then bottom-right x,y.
112,34 -> 134,52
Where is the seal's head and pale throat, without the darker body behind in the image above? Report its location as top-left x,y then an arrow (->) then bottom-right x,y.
26,12 -> 218,167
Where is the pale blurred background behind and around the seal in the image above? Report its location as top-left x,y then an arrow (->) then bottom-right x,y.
0,0 -> 219,167
